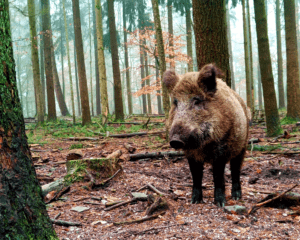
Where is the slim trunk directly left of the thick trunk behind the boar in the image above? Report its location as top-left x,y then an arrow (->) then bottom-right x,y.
185,4 -> 194,72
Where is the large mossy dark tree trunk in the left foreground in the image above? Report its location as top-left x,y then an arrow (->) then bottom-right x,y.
0,0 -> 58,237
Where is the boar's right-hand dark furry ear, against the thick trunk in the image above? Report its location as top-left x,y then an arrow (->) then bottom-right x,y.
198,64 -> 223,93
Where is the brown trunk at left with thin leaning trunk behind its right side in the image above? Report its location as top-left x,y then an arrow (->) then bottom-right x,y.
42,0 -> 56,121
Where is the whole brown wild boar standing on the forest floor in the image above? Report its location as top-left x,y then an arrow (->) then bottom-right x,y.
163,64 -> 250,207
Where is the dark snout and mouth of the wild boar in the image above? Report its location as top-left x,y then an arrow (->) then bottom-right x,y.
170,123 -> 210,149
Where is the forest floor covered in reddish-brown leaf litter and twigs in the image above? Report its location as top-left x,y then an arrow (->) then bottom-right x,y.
26,114 -> 300,240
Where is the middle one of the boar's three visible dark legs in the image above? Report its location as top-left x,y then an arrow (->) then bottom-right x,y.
213,159 -> 226,207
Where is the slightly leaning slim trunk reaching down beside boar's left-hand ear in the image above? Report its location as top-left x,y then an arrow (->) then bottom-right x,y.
151,0 -> 170,119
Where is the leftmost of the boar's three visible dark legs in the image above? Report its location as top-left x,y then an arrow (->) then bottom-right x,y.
188,158 -> 203,203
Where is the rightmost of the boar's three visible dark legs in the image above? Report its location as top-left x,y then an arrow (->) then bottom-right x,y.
230,148 -> 245,200
